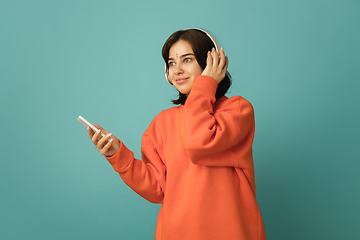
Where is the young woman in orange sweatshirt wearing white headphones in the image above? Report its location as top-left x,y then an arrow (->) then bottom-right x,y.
88,29 -> 265,240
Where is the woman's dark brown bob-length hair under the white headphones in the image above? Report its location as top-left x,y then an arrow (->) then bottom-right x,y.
162,29 -> 231,104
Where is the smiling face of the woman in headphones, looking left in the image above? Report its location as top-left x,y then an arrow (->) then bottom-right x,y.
168,40 -> 203,94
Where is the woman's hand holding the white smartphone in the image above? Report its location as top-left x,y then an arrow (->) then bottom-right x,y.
88,124 -> 120,157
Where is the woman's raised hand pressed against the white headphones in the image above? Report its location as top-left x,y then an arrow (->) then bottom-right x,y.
201,48 -> 229,83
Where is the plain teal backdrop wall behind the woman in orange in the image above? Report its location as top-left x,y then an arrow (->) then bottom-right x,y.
0,0 -> 360,240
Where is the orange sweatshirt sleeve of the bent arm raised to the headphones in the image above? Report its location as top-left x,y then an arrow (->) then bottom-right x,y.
182,75 -> 255,167
